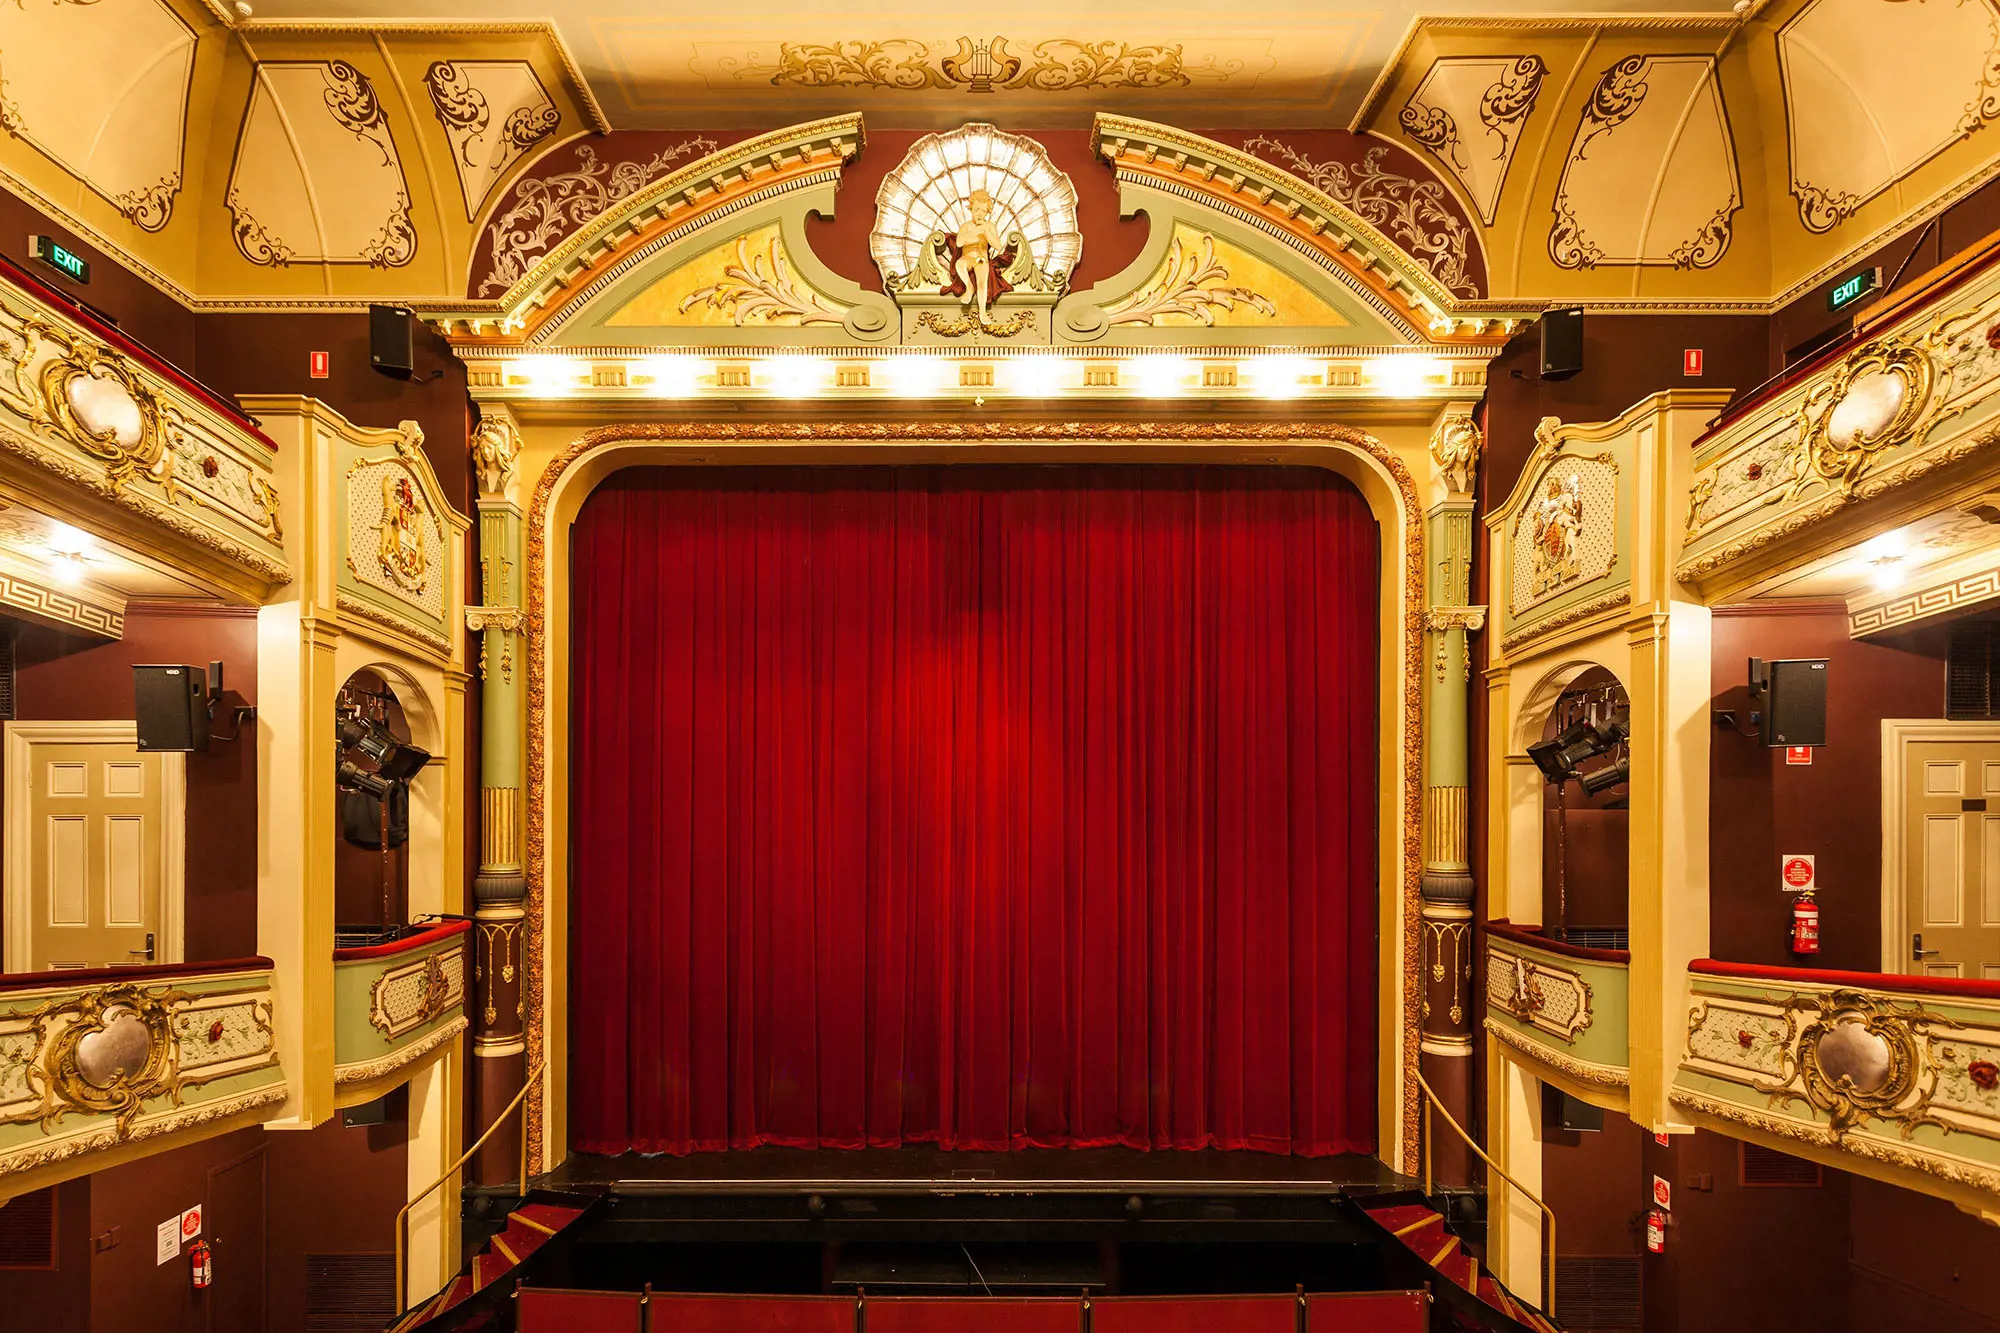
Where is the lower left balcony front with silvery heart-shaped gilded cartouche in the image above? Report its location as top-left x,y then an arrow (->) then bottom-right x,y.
0,959 -> 286,1197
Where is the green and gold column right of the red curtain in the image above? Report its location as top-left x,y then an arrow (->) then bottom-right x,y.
1420,402 -> 1486,1185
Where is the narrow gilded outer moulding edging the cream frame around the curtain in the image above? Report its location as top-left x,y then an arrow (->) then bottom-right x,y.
516,420 -> 1426,1171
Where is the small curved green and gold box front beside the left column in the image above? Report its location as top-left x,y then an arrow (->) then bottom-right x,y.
334,921 -> 472,1107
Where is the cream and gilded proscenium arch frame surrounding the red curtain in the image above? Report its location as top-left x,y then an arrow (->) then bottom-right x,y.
522,422 -> 1424,1171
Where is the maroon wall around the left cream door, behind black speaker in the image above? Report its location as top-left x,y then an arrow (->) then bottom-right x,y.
14,606 -> 256,961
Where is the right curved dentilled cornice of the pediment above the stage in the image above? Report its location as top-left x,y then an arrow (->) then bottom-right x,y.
1090,114 -> 1538,344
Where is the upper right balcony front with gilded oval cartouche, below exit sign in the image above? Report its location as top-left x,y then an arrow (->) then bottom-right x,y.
1676,248 -> 2000,604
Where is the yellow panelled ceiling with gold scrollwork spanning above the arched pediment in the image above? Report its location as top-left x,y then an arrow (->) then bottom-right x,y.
0,0 -> 2000,310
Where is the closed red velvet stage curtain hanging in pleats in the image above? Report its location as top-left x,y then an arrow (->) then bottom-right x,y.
570,466 -> 1378,1155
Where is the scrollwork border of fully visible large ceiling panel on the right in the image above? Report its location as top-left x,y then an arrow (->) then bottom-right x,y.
1548,52 -> 1744,270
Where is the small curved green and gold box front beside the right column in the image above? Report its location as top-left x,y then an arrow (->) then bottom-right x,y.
1486,921 -> 1632,1105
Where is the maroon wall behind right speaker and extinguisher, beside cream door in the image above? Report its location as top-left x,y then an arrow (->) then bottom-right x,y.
1708,604 -> 1946,973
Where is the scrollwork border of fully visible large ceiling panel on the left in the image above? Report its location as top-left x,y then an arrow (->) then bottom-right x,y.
222,56 -> 418,270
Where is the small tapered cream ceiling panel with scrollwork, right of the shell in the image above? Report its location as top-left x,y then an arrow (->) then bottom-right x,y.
1398,56 -> 1548,226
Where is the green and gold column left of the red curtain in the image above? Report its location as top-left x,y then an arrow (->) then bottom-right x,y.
466,406 -> 528,1185
